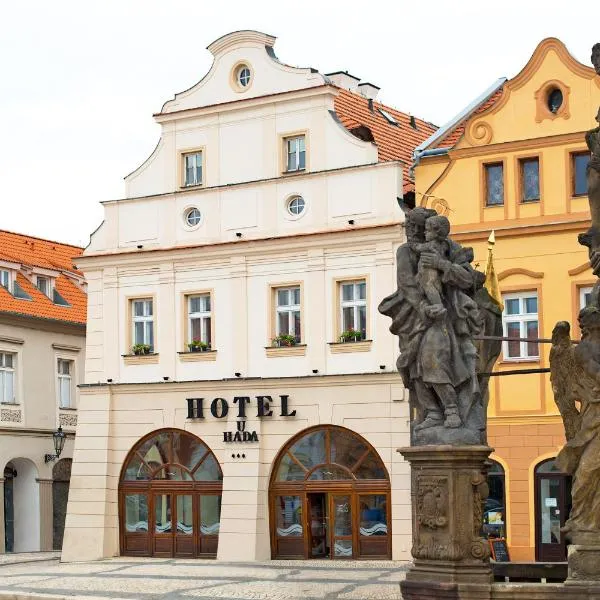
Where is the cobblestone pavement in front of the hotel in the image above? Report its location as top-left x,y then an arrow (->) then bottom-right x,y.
0,555 -> 408,600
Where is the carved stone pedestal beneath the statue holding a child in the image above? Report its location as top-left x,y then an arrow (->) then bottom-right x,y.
398,445 -> 493,600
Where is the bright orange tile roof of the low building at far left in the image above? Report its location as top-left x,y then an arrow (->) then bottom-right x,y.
0,230 -> 87,324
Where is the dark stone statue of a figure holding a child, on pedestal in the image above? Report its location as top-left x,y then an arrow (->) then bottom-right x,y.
379,207 -> 501,445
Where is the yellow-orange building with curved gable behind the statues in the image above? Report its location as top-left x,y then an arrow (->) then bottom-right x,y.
415,38 -> 600,560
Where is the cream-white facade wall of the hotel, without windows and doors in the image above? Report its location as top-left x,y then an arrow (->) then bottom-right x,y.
63,32 -> 410,560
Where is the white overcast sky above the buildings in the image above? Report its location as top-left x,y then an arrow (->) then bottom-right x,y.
0,0 -> 600,246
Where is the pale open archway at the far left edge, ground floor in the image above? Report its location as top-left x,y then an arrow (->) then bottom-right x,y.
4,458 -> 40,552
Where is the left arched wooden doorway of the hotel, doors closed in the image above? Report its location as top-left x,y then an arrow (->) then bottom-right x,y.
119,429 -> 223,558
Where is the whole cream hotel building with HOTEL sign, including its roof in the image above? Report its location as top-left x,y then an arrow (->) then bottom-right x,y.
63,31 -> 435,561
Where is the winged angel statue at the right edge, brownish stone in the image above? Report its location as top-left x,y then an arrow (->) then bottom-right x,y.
550,304 -> 600,545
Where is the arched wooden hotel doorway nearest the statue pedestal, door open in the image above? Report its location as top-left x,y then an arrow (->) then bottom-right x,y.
269,425 -> 391,559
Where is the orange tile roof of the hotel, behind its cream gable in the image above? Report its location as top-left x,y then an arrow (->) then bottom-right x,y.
335,88 -> 437,192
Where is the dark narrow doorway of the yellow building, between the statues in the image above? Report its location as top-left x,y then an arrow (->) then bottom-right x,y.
534,458 -> 571,562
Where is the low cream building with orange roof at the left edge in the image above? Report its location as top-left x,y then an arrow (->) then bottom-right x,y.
0,231 -> 87,553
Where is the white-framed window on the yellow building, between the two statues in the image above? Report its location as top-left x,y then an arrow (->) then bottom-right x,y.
502,292 -> 540,360
